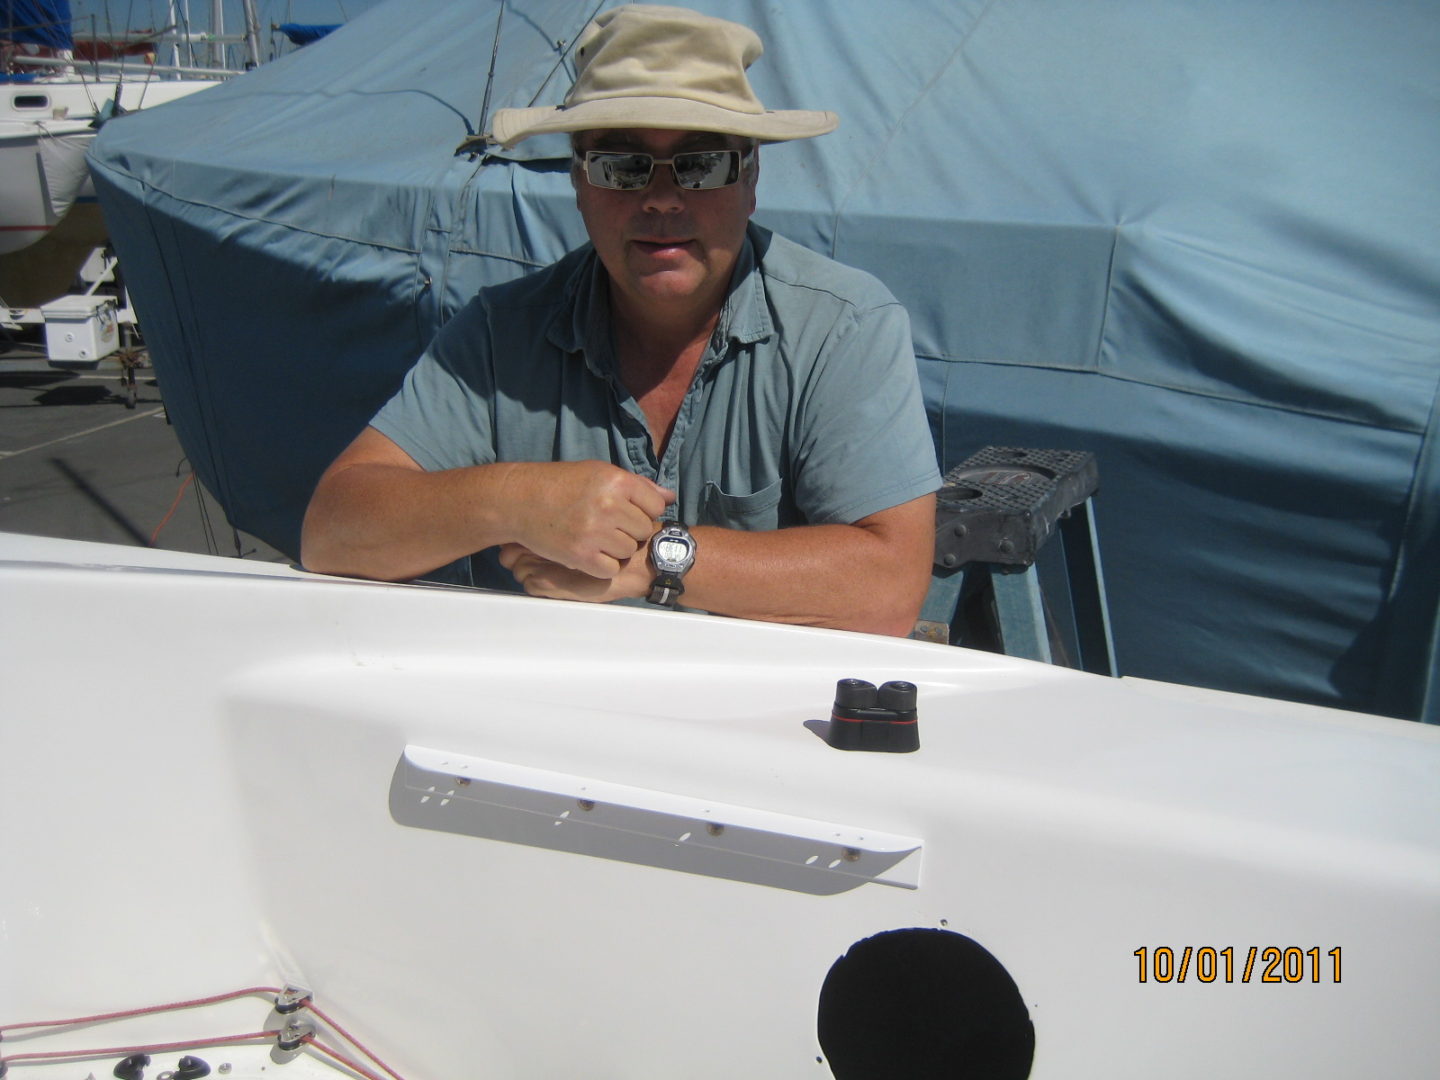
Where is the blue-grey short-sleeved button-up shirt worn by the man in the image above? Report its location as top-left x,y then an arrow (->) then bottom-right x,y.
372,223 -> 940,589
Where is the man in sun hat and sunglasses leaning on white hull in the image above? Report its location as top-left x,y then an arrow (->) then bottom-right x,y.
302,4 -> 939,635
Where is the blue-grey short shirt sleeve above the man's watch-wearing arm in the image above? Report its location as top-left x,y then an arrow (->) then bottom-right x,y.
793,301 -> 940,524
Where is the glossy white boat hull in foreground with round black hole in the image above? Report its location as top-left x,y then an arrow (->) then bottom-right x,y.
0,536 -> 1440,1080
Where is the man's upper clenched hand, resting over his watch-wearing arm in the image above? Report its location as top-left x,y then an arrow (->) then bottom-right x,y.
501,461 -> 675,584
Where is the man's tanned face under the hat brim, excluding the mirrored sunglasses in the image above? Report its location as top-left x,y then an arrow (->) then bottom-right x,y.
572,128 -> 759,311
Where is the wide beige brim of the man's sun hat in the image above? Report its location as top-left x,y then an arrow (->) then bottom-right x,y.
490,96 -> 840,150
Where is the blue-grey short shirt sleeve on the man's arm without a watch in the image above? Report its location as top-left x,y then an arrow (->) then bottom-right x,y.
370,300 -> 495,471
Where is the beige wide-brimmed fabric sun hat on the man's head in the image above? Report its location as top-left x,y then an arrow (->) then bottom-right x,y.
490,4 -> 840,147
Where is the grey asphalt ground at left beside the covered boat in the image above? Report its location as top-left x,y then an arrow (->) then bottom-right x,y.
0,341 -> 289,562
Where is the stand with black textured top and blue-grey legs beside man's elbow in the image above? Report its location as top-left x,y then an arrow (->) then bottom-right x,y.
913,446 -> 1117,675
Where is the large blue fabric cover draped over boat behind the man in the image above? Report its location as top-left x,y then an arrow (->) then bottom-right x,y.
92,0 -> 1440,720
